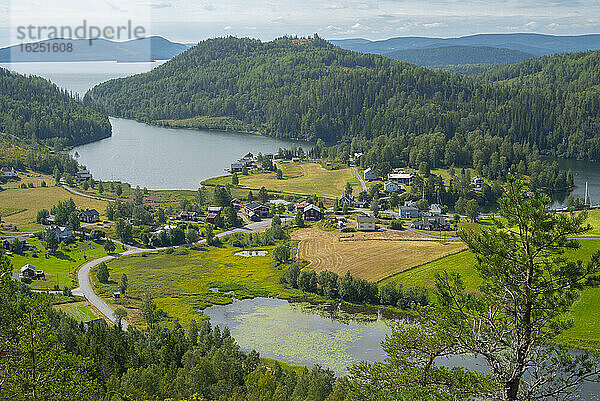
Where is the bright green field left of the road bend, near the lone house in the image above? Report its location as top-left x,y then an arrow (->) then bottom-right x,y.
9,238 -> 106,290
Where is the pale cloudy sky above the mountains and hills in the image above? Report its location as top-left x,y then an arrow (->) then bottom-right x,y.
0,0 -> 600,45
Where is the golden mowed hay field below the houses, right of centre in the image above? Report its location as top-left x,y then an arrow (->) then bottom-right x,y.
292,228 -> 465,281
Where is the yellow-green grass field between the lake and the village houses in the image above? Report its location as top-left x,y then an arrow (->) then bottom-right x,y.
204,162 -> 357,198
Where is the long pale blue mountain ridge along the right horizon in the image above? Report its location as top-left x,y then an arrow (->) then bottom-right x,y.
330,33 -> 600,56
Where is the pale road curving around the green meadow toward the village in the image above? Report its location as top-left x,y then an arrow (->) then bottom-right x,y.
73,217 -> 292,330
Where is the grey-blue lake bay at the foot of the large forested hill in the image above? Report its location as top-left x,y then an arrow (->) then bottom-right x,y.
72,118 -> 310,189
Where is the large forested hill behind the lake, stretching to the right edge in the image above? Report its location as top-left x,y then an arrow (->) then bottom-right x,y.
86,37 -> 600,159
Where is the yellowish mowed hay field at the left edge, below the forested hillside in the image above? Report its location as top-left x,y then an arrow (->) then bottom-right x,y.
0,184 -> 106,227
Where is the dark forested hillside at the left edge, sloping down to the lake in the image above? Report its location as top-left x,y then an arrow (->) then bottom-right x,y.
0,68 -> 111,145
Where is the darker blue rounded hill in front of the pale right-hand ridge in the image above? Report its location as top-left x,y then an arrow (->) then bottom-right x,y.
385,46 -> 535,67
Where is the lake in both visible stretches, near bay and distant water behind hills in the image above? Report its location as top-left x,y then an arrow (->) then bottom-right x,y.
0,61 -> 311,190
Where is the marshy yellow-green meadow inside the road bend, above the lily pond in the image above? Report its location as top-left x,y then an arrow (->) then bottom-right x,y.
90,246 -> 301,326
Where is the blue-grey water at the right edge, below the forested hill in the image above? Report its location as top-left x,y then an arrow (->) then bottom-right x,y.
552,159 -> 600,208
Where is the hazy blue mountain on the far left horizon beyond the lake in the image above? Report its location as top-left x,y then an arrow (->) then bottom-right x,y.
0,36 -> 192,63
